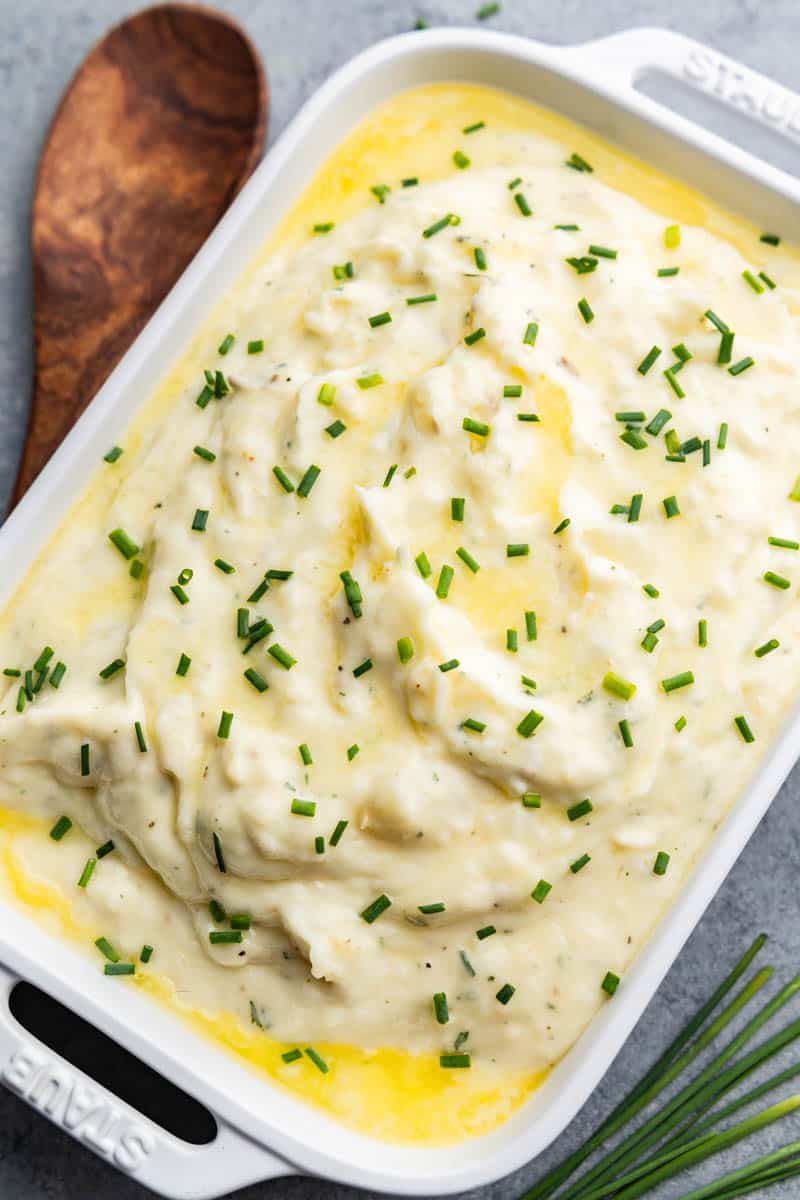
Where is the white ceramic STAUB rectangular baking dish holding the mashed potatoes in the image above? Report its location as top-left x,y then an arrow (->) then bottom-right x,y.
0,21 -> 800,1200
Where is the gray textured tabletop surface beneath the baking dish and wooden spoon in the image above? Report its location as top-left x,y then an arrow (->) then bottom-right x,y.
0,0 -> 800,1200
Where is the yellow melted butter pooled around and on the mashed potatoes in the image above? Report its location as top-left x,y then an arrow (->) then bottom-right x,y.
0,84 -> 796,1144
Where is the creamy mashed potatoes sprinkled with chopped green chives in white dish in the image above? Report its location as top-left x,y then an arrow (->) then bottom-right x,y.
0,88 -> 800,1133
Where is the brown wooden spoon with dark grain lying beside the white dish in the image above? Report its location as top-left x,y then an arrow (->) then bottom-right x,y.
12,4 -> 267,503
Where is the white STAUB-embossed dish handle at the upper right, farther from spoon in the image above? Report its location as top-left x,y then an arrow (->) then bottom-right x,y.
567,28 -> 800,158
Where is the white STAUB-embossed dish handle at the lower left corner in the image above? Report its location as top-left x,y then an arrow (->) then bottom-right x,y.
0,962 -> 296,1200
